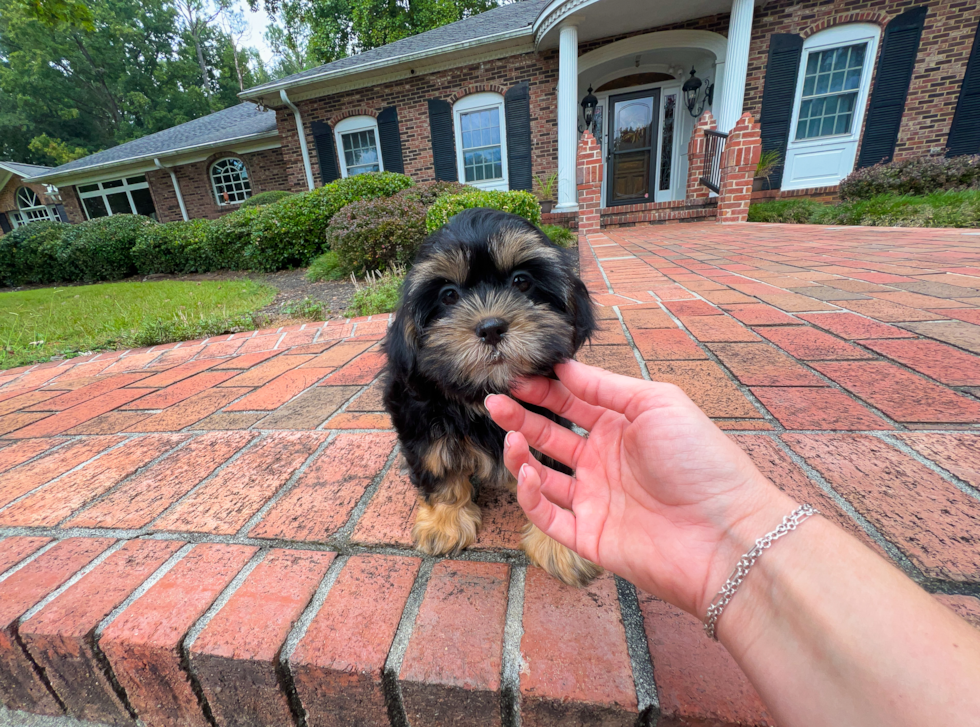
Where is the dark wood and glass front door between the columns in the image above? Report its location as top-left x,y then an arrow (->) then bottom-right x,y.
606,88 -> 660,207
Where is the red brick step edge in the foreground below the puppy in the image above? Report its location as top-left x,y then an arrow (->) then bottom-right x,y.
0,536 -> 772,727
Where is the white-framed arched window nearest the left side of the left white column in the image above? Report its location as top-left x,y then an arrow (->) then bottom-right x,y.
453,93 -> 509,192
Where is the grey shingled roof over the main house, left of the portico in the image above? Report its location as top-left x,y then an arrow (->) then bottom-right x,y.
239,0 -> 551,98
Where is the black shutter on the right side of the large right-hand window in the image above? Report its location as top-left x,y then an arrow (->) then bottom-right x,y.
857,7 -> 927,169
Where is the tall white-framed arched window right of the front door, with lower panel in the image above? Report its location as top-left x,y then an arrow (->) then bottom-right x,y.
782,23 -> 881,189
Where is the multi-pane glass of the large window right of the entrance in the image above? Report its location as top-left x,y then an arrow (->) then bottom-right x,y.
796,43 -> 868,140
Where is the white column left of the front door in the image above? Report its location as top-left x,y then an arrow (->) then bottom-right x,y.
555,25 -> 578,212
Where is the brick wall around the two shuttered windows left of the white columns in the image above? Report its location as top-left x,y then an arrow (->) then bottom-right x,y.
284,51 -> 558,189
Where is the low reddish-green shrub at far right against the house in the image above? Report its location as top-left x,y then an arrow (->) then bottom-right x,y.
838,155 -> 980,200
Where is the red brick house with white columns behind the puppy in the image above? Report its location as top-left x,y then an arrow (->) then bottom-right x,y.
30,0 -> 980,226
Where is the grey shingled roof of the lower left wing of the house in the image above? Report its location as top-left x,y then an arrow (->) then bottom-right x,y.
31,103 -> 276,179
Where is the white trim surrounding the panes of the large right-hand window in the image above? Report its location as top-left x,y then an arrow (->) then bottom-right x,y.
782,23 -> 881,189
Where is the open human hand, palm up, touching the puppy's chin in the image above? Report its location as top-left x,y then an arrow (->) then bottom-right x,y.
486,361 -> 794,618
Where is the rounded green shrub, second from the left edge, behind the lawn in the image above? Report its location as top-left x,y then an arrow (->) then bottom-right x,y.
53,215 -> 157,282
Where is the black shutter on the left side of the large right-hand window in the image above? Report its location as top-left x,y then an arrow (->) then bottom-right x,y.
759,33 -> 803,189
